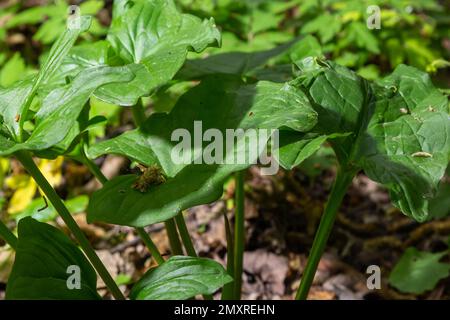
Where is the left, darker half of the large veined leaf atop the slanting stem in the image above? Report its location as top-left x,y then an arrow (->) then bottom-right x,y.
296,58 -> 374,163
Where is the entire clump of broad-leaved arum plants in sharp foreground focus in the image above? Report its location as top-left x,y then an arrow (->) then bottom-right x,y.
0,0 -> 450,299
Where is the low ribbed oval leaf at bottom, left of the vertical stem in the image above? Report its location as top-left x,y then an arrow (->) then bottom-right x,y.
130,256 -> 232,300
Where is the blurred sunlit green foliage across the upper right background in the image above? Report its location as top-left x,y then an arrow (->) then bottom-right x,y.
181,0 -> 450,79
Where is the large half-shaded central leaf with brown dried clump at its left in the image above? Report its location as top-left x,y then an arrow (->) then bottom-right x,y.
88,77 -> 317,226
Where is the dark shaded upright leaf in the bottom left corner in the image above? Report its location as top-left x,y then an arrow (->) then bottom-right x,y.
6,217 -> 99,300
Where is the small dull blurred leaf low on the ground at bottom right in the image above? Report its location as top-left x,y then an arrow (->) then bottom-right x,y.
389,248 -> 450,294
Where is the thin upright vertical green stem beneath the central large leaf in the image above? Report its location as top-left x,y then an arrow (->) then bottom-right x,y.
233,171 -> 245,300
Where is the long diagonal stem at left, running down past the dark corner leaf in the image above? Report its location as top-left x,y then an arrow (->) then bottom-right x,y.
15,151 -> 125,300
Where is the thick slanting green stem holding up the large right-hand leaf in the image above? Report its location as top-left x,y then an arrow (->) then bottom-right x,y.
295,169 -> 354,300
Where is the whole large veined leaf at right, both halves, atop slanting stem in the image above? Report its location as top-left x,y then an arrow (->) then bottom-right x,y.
280,59 -> 450,221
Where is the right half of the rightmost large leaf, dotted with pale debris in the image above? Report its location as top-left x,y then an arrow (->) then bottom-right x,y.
359,65 -> 450,221
